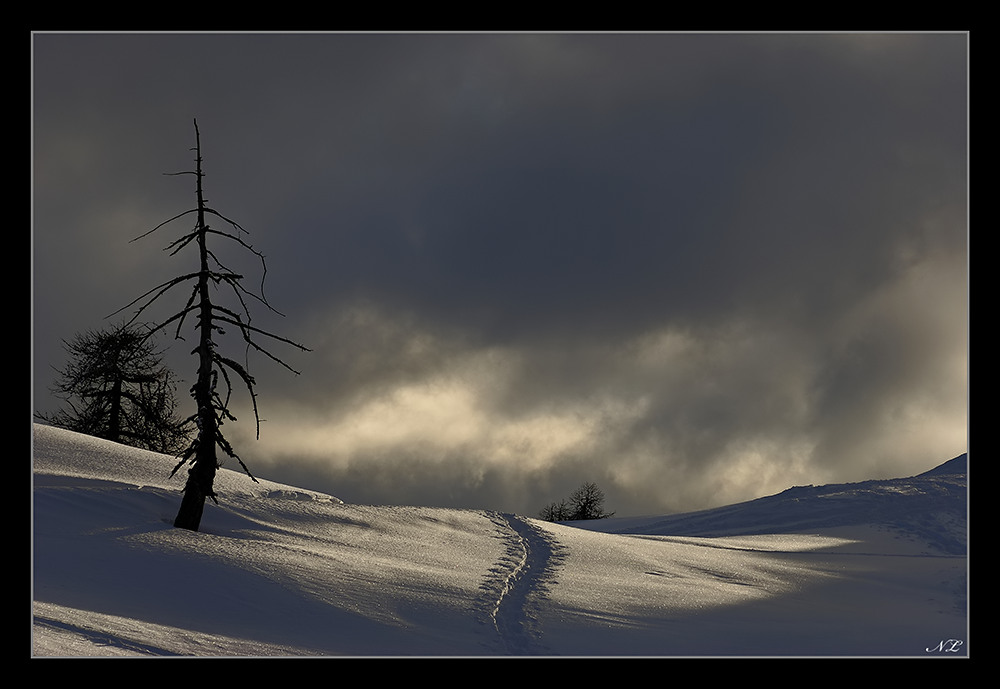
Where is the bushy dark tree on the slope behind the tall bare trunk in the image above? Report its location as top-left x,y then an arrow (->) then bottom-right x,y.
35,324 -> 191,454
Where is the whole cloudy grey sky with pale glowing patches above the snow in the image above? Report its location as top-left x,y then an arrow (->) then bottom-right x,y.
32,33 -> 969,516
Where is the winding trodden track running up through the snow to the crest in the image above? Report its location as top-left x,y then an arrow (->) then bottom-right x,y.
480,512 -> 562,655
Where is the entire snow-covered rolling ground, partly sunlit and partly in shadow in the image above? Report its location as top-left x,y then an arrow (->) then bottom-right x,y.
32,425 -> 968,657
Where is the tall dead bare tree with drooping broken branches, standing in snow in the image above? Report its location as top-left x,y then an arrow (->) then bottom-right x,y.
112,120 -> 309,531
